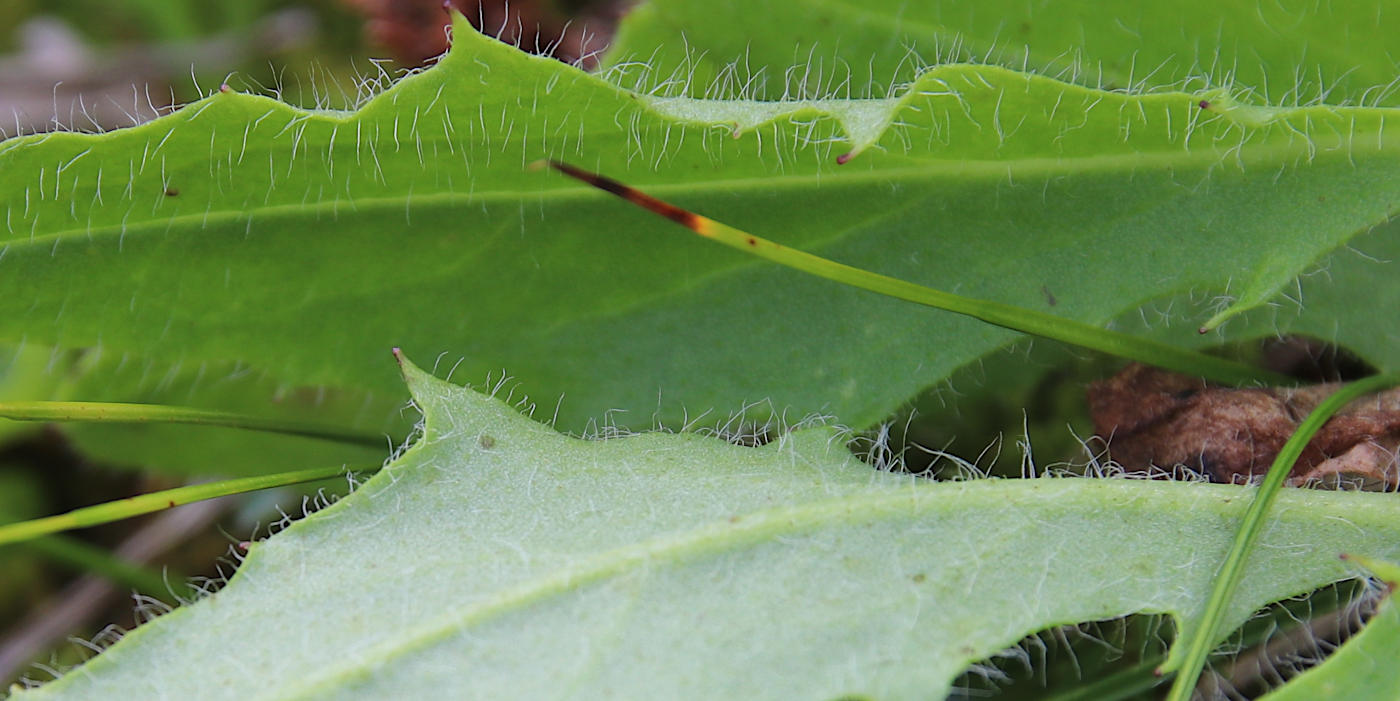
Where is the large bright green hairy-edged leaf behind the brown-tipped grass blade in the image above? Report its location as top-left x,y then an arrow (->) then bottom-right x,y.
0,15 -> 1400,431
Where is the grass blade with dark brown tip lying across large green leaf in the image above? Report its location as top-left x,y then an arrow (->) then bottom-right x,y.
547,161 -> 1294,385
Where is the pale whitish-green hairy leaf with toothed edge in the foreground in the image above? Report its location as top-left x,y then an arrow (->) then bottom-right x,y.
20,358 -> 1400,700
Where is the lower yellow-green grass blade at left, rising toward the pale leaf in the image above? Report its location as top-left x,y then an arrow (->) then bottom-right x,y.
0,466 -> 378,546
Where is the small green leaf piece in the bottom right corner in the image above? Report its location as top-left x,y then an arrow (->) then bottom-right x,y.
1263,554 -> 1400,701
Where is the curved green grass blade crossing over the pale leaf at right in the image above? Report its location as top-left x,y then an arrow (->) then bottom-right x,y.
1163,374 -> 1400,701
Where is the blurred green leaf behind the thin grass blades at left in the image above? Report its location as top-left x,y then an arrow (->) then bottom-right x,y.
0,343 -> 400,479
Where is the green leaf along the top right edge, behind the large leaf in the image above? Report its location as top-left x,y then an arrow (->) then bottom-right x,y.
602,0 -> 1400,106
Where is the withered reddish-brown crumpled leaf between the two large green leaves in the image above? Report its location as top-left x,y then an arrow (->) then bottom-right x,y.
1089,364 -> 1400,488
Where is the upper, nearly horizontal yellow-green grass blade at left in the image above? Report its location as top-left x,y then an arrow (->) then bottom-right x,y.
0,402 -> 386,446
